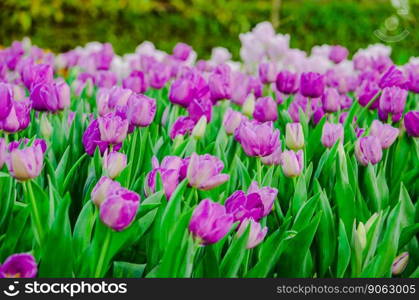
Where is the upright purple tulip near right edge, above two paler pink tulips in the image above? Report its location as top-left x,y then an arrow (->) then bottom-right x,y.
378,86 -> 408,122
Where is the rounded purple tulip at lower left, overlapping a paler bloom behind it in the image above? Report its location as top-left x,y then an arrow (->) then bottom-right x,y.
100,188 -> 141,231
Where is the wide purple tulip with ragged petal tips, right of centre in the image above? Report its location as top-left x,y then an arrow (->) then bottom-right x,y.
234,121 -> 279,157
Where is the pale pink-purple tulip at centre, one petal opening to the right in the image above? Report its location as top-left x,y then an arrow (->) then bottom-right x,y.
186,153 -> 230,190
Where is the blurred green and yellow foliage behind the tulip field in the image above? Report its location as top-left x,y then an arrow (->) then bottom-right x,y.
0,0 -> 419,63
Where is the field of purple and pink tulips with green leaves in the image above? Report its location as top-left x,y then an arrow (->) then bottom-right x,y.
0,22 -> 419,278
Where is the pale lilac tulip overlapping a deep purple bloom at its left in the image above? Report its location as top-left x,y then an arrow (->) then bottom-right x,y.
98,113 -> 128,145
